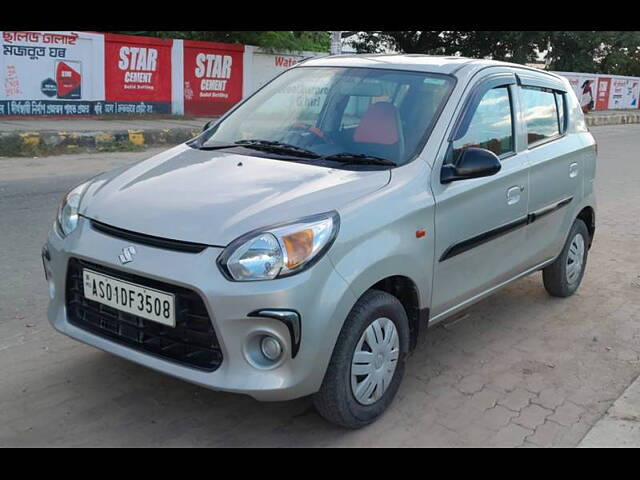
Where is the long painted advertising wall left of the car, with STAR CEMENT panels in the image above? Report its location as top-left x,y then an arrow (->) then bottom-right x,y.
0,31 -> 322,117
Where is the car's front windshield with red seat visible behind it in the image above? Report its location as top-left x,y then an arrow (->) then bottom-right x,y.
192,66 -> 453,165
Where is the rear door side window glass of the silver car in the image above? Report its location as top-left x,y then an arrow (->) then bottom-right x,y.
520,87 -> 564,145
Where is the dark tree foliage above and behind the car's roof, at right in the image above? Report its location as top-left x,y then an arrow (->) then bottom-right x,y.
352,31 -> 640,76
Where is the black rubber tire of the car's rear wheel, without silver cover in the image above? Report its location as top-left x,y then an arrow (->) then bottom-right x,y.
542,219 -> 591,297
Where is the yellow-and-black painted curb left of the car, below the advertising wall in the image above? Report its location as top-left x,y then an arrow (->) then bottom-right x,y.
0,128 -> 200,157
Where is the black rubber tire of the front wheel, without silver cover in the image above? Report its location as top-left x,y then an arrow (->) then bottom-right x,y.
314,290 -> 409,429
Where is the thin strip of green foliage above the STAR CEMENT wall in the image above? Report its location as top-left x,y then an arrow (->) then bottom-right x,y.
114,30 -> 330,52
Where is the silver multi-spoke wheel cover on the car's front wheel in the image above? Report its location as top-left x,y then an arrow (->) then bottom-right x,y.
351,318 -> 400,405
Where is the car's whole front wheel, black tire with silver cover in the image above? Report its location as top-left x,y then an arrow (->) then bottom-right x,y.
314,290 -> 409,428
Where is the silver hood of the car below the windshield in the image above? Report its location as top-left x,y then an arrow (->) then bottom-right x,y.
80,145 -> 391,246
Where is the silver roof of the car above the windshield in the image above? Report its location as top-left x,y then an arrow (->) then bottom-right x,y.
298,53 -> 560,82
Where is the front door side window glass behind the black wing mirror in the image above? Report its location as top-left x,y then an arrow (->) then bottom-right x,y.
453,87 -> 514,163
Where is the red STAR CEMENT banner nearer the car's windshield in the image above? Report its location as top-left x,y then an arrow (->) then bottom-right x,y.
184,40 -> 244,115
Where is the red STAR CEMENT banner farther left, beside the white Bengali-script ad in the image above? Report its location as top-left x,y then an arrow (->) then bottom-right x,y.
104,33 -> 173,104
